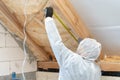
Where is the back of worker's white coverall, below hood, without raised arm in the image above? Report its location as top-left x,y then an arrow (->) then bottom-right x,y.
59,54 -> 101,80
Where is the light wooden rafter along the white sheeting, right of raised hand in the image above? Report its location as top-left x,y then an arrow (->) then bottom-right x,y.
53,0 -> 91,38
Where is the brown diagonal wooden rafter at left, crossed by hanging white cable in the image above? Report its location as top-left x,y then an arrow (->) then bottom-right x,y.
0,0 -> 49,61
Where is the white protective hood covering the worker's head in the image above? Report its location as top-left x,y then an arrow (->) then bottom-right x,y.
76,38 -> 101,61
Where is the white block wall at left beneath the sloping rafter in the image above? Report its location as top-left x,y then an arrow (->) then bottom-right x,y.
0,24 -> 37,76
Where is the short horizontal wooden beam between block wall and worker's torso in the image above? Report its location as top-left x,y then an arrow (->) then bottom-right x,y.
38,62 -> 59,70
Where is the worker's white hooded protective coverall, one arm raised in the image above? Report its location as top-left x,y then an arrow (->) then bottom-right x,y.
45,17 -> 101,80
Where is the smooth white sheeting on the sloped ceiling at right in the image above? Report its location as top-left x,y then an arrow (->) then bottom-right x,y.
70,0 -> 120,55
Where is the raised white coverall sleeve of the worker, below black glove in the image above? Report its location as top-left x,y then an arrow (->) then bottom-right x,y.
45,17 -> 72,66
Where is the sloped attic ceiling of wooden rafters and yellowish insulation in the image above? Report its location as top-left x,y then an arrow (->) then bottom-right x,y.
0,0 -> 90,61
